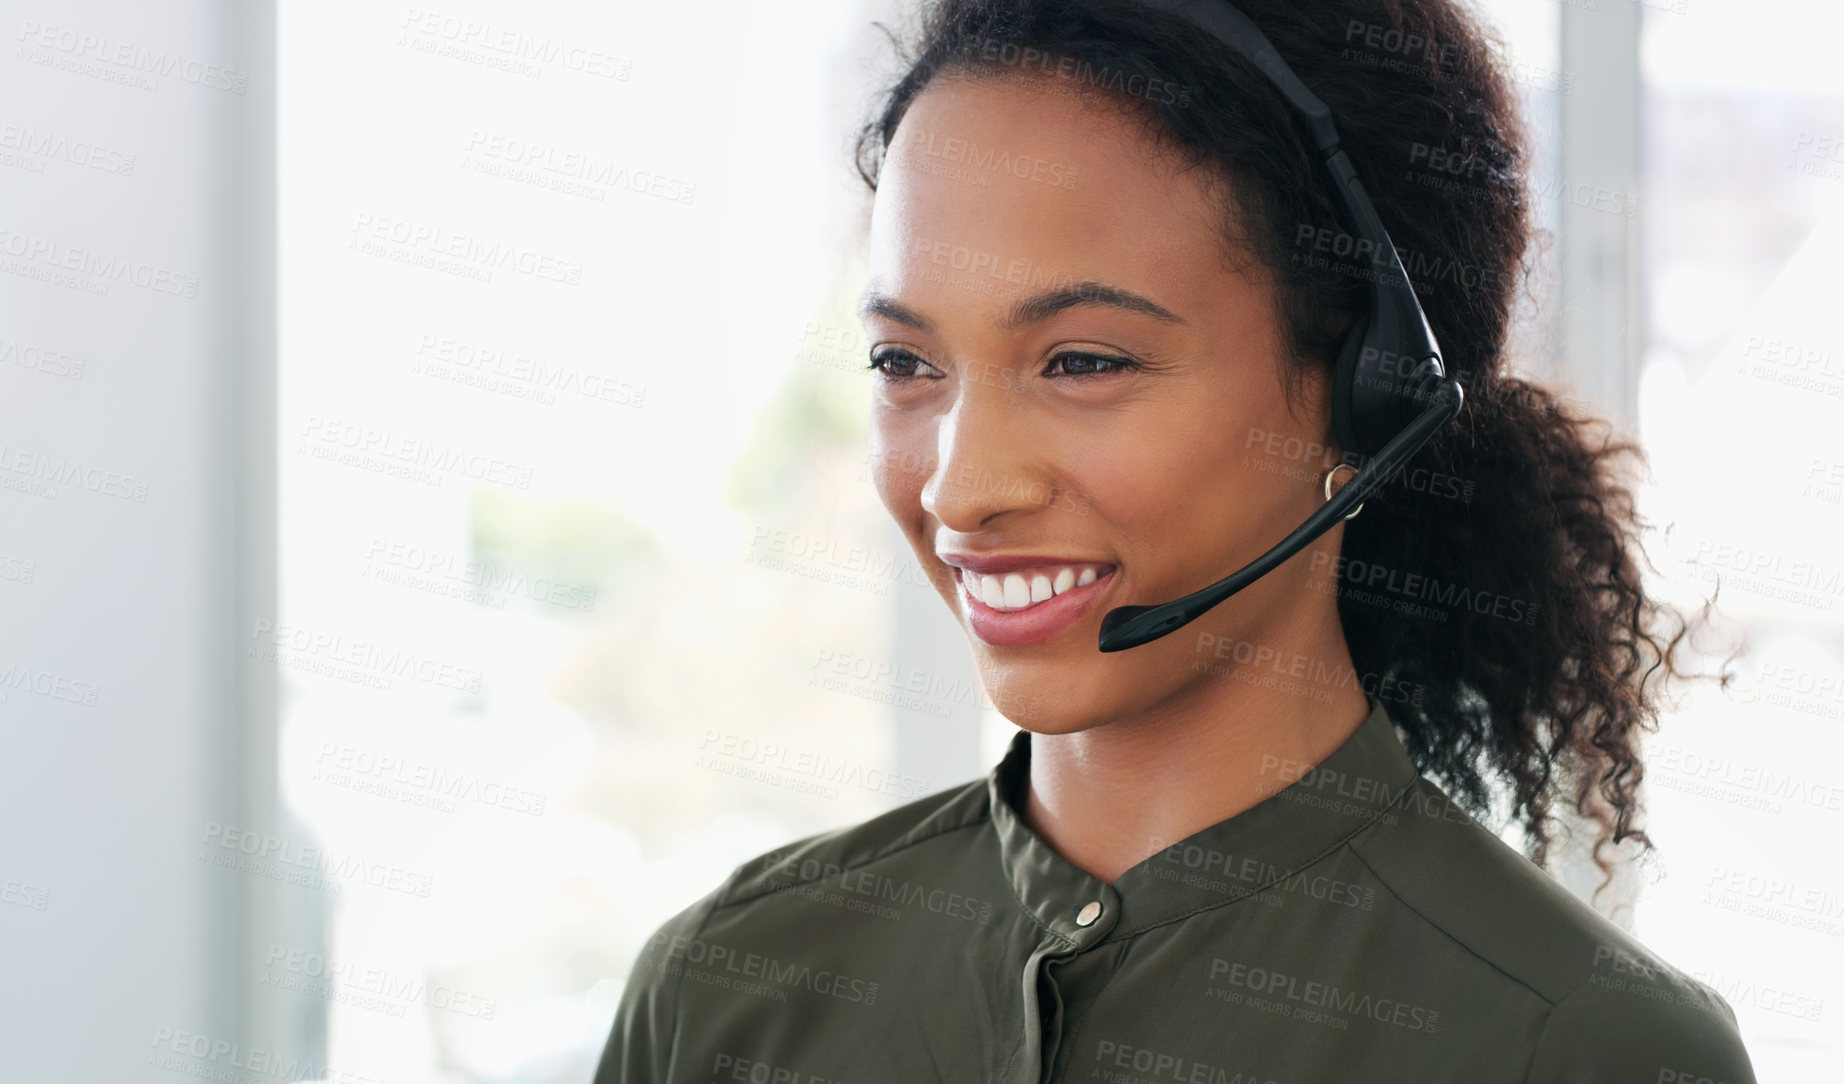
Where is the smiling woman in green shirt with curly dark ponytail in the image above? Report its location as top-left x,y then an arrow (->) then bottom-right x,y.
596,0 -> 1754,1084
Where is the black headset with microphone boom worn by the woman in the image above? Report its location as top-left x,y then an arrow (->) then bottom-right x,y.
1101,0 -> 1464,651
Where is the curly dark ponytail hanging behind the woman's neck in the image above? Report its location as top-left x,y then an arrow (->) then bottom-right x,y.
1339,370 -> 1709,885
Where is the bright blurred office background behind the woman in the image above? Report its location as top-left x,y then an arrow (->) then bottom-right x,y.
0,0 -> 1844,1084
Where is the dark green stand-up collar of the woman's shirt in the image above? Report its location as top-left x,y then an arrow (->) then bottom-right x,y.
987,695 -> 1420,948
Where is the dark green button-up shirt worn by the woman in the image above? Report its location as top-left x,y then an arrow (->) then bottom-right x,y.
596,697 -> 1754,1084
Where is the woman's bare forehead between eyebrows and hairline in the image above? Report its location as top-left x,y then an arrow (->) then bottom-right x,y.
870,76 -> 1223,302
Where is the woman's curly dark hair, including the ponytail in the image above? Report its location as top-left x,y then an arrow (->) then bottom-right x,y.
854,0 -> 1732,896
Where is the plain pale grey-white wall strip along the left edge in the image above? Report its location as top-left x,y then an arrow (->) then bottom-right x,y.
0,0 -> 280,1082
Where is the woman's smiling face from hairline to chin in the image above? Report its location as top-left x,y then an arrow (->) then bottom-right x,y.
863,77 -> 1342,734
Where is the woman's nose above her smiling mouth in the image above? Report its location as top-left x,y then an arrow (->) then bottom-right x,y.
922,382 -> 1057,535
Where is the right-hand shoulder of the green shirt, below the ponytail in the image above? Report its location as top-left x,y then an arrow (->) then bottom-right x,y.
1352,778 -> 1754,1084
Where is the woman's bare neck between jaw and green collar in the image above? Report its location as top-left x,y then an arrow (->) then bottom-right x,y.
1020,623 -> 1370,885
